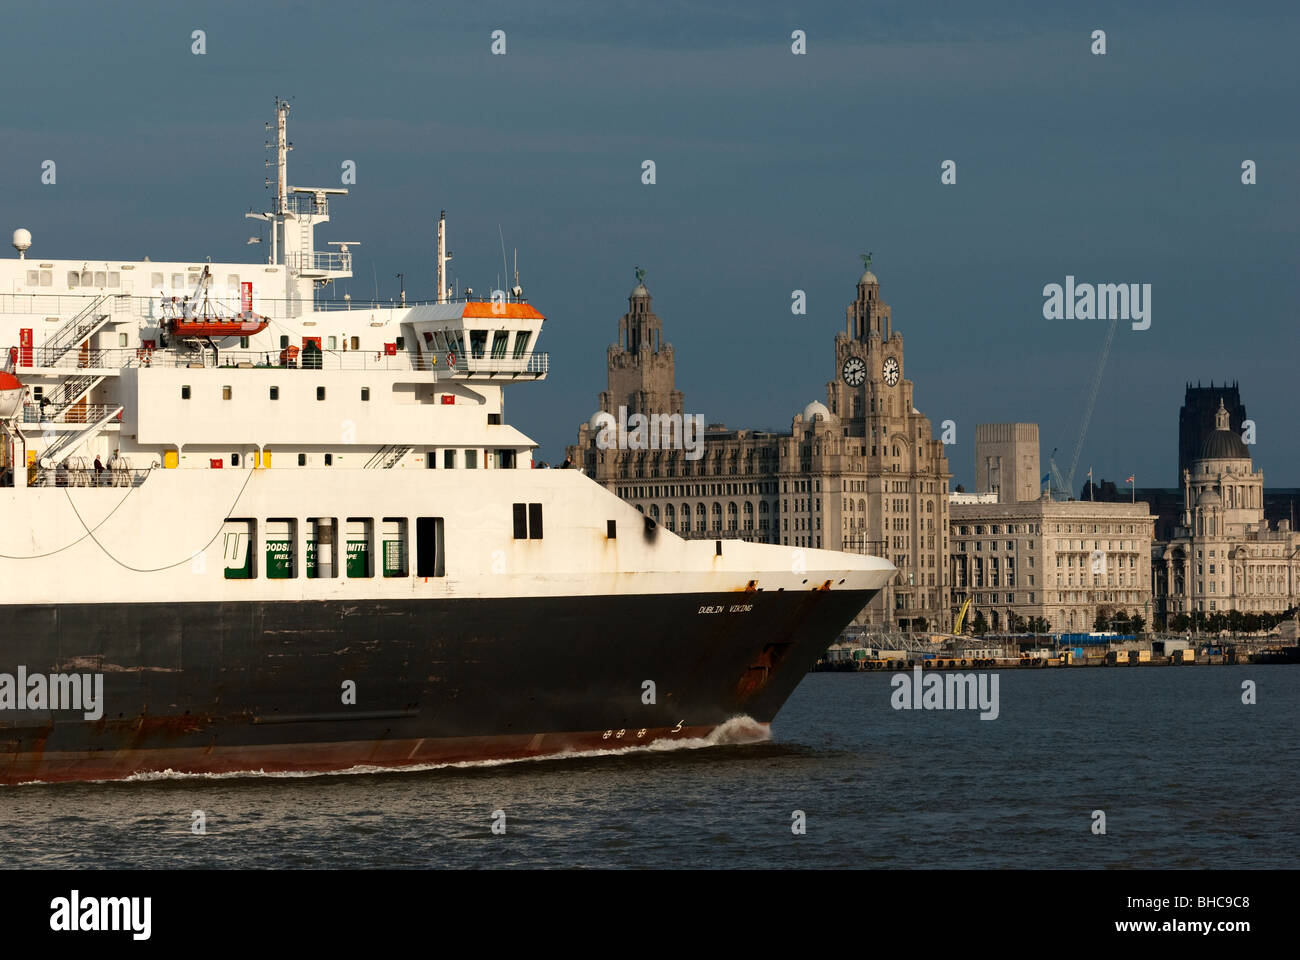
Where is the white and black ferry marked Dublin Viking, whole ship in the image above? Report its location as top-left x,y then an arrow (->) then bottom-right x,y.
0,100 -> 894,784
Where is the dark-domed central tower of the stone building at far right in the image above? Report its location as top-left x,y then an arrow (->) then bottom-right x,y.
1183,399 -> 1264,537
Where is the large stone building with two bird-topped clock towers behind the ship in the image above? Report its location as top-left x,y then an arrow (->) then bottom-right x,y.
568,261 -> 952,630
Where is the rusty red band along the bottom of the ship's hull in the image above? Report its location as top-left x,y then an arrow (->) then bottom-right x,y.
0,721 -> 768,784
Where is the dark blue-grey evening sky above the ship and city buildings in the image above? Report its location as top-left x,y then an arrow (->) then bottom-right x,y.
0,0 -> 1300,489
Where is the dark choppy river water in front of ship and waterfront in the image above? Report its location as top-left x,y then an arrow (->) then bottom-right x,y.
0,666 -> 1300,868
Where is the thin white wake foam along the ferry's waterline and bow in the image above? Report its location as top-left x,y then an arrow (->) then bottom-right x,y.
30,714 -> 771,786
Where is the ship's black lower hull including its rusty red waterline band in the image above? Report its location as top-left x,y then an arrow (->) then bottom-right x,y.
0,582 -> 874,783
